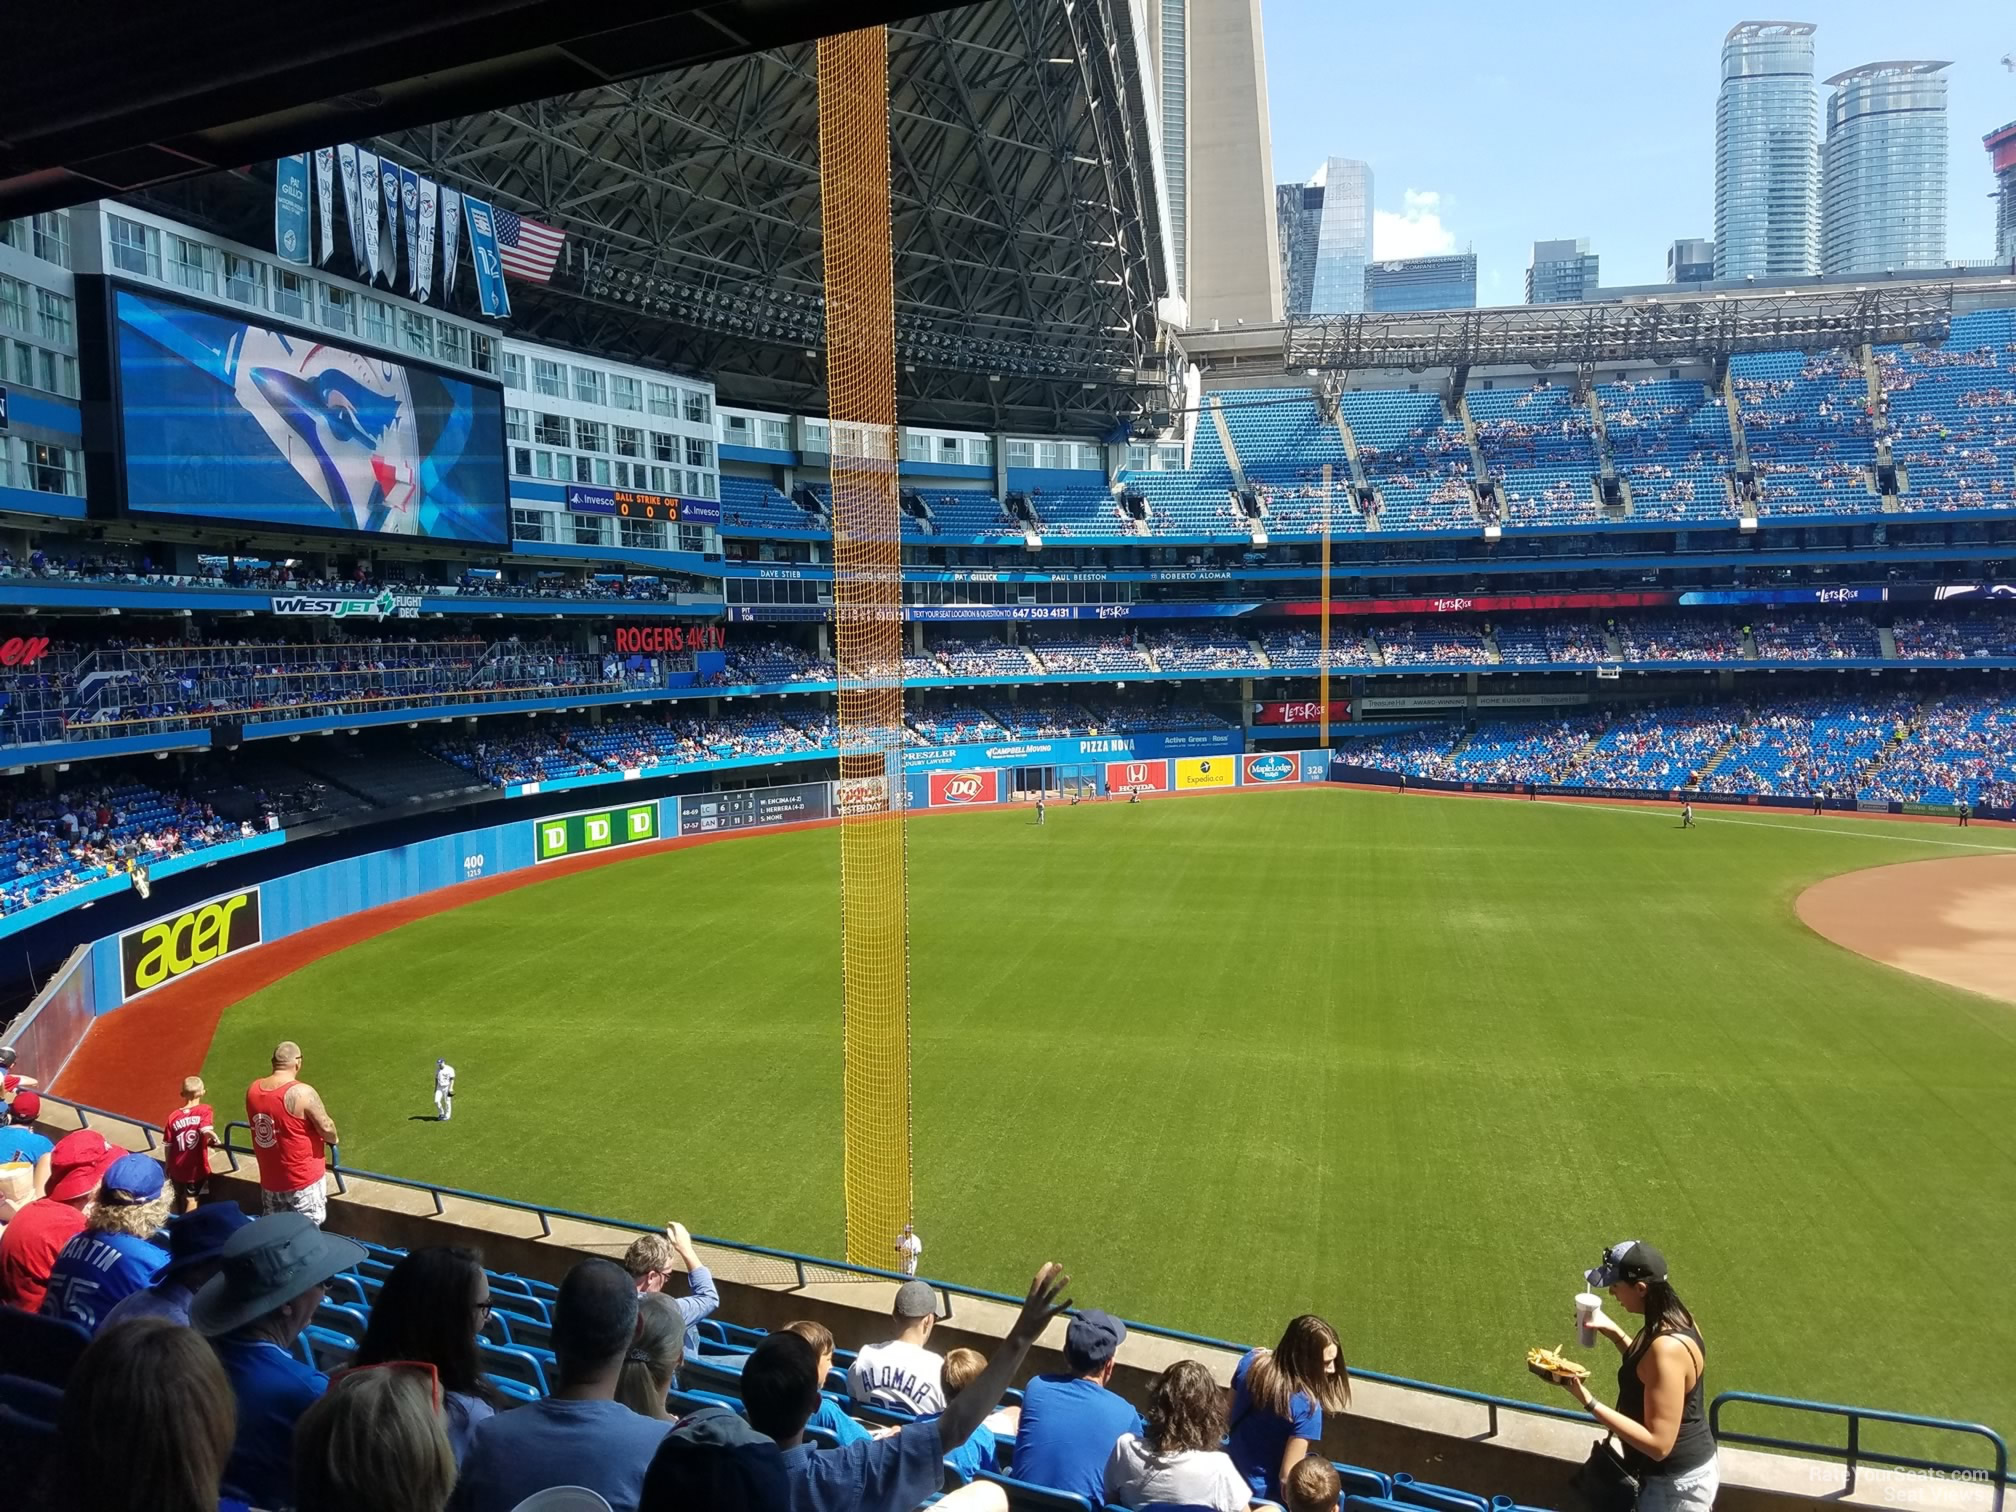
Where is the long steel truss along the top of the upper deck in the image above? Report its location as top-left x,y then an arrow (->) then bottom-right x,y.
1282,284 -> 1954,373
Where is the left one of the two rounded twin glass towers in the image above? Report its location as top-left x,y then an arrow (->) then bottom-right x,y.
1716,20 -> 1820,278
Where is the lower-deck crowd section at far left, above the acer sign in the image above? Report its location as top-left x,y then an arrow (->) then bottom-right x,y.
0,780 -> 258,913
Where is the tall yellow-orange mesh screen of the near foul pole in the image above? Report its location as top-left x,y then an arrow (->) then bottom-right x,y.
818,26 -> 911,1266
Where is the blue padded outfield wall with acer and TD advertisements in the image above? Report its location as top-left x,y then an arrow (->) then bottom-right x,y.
3,758 -> 1331,1075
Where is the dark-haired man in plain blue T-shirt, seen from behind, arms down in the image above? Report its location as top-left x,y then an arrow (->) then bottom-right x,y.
450,1260 -> 671,1512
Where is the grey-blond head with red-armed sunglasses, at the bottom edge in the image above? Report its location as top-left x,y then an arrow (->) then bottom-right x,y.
294,1361 -> 456,1512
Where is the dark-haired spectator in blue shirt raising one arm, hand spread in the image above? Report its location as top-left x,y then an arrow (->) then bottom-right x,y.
742,1264 -> 1070,1512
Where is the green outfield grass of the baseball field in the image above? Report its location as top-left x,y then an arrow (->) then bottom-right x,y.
206,790 -> 2016,1454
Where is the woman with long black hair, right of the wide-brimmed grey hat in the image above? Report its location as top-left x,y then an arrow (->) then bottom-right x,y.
355,1244 -> 498,1466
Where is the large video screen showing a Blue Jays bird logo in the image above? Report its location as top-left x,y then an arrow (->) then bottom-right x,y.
113,288 -> 510,544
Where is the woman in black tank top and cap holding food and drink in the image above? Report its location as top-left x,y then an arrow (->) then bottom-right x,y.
1562,1240 -> 1722,1512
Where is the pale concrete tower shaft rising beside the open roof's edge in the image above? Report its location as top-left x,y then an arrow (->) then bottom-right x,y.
1145,0 -> 1280,329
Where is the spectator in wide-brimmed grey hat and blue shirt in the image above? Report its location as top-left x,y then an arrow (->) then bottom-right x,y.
190,1214 -> 365,1506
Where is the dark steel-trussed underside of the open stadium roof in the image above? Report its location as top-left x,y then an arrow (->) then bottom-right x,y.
126,0 -> 1173,433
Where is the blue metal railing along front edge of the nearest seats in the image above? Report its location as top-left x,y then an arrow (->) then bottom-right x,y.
27,1095 -> 2008,1512
